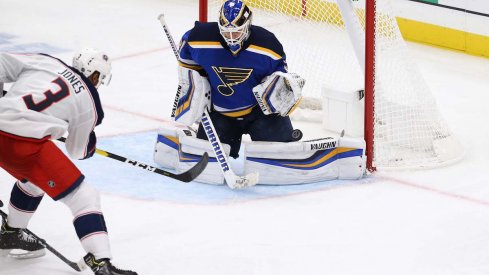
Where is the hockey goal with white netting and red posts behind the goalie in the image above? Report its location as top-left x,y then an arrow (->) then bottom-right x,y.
199,0 -> 464,171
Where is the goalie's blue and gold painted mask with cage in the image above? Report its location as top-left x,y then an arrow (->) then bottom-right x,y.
218,0 -> 252,53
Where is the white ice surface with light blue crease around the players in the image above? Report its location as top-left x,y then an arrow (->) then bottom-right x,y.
0,0 -> 489,275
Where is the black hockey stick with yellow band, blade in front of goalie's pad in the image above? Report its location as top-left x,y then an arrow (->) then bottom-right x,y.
58,137 -> 209,182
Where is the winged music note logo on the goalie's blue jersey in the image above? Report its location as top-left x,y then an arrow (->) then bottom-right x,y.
212,66 -> 253,96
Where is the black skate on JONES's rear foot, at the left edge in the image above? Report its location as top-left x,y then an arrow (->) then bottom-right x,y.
0,219 -> 46,259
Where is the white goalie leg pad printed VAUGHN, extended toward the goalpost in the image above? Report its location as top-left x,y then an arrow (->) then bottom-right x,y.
245,138 -> 365,185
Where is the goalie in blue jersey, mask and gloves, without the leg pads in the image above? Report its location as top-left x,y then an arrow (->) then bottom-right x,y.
176,0 -> 304,158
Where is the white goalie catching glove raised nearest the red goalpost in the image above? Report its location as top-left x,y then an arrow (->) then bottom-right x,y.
253,72 -> 306,116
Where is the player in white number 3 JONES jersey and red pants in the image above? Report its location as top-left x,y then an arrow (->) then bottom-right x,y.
0,48 -> 137,275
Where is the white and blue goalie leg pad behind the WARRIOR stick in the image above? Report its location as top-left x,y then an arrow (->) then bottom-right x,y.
154,124 -> 230,184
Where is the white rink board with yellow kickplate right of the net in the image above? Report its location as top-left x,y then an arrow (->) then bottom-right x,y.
396,0 -> 489,57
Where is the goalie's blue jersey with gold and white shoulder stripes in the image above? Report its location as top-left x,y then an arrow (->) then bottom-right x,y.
179,22 -> 287,117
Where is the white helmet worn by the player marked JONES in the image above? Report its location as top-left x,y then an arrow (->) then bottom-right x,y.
73,48 -> 112,88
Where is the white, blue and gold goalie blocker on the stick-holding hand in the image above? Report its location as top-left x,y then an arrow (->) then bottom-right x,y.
175,66 -> 211,126
